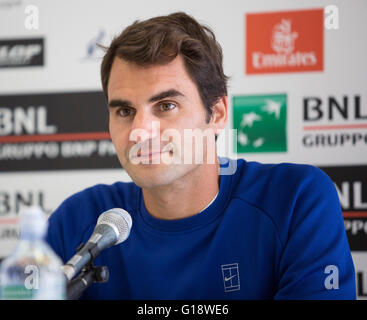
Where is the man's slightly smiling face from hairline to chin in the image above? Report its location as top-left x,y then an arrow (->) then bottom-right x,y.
108,56 -> 220,188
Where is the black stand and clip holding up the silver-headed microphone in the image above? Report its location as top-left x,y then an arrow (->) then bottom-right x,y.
66,243 -> 109,300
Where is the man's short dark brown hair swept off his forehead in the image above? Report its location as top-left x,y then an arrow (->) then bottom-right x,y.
101,12 -> 228,121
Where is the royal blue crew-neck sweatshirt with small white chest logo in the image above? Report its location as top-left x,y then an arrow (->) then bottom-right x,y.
47,159 -> 356,299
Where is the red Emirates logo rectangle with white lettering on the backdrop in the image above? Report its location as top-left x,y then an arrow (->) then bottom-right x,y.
245,9 -> 324,74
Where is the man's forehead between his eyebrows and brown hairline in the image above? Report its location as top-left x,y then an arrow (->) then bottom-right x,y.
108,56 -> 197,99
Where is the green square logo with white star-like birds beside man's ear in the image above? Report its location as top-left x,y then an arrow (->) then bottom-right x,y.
233,94 -> 287,153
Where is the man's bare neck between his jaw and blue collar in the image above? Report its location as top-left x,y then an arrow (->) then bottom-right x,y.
142,162 -> 219,220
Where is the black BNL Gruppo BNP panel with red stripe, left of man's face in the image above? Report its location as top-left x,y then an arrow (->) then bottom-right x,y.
0,91 -> 120,171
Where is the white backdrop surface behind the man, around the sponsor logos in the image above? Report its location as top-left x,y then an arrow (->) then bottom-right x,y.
0,0 -> 367,298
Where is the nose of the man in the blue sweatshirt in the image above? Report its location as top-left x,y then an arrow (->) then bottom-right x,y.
130,110 -> 160,141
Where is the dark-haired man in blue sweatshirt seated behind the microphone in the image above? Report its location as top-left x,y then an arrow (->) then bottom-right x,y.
47,13 -> 355,299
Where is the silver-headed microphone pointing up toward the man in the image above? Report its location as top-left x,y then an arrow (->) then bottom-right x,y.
61,208 -> 132,280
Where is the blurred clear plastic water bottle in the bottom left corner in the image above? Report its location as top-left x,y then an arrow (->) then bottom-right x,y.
0,207 -> 66,300
